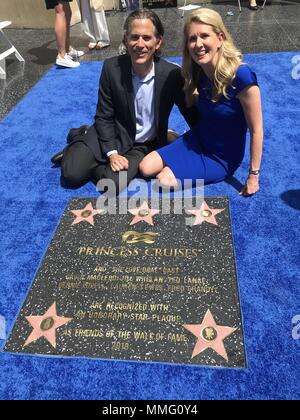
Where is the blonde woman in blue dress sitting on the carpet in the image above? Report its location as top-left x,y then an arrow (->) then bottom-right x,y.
140,9 -> 263,196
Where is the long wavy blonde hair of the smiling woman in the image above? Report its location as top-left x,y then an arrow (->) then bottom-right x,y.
182,9 -> 242,106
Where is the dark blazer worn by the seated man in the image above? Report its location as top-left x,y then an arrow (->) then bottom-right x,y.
84,55 -> 197,162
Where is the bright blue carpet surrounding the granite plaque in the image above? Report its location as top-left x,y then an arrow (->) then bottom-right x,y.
0,53 -> 300,399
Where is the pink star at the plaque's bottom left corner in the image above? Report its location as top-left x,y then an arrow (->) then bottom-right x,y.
24,302 -> 73,348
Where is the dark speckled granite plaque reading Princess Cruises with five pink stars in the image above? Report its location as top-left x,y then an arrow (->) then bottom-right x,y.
4,197 -> 246,368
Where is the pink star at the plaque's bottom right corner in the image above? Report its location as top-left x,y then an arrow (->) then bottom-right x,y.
183,309 -> 237,362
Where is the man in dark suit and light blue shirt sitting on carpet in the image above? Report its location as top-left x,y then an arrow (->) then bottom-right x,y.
52,9 -> 197,192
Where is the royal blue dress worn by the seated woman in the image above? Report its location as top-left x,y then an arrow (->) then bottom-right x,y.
157,64 -> 257,184
